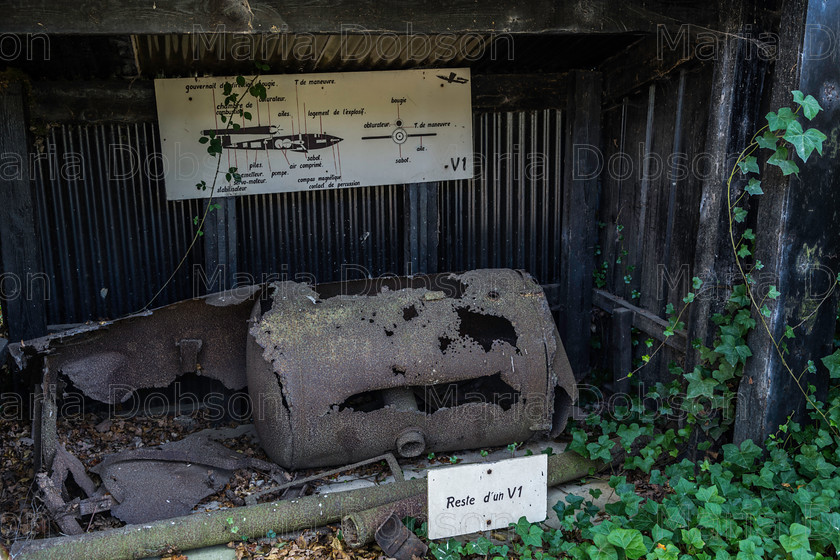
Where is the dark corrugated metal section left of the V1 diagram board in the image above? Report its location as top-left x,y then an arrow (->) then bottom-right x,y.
32,124 -> 203,324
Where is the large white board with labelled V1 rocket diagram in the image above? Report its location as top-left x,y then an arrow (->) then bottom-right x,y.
155,68 -> 473,200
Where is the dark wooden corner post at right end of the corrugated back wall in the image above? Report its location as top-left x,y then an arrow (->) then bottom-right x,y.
557,71 -> 603,379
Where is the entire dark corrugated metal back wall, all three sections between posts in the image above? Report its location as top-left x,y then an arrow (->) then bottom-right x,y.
33,110 -> 563,325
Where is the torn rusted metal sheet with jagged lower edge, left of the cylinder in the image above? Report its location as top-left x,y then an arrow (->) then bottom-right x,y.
9,286 -> 262,404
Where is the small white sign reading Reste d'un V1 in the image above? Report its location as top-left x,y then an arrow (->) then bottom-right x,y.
429,453 -> 548,539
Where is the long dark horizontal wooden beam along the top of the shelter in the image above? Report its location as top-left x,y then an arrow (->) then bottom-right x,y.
0,0 -> 716,35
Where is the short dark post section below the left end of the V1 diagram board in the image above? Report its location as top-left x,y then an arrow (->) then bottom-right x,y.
204,197 -> 236,295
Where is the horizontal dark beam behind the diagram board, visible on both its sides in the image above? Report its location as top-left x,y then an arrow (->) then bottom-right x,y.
30,74 -> 569,125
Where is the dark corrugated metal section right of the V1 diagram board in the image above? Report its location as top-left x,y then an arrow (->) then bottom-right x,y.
439,110 -> 563,284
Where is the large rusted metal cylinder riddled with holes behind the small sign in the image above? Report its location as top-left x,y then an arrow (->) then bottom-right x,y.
247,269 -> 575,468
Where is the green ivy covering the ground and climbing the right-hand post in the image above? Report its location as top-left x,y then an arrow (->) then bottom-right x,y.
420,91 -> 840,560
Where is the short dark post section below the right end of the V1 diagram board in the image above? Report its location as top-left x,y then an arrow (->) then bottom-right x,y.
404,183 -> 440,274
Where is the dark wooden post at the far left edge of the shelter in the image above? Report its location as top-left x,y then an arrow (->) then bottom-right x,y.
0,82 -> 47,342
